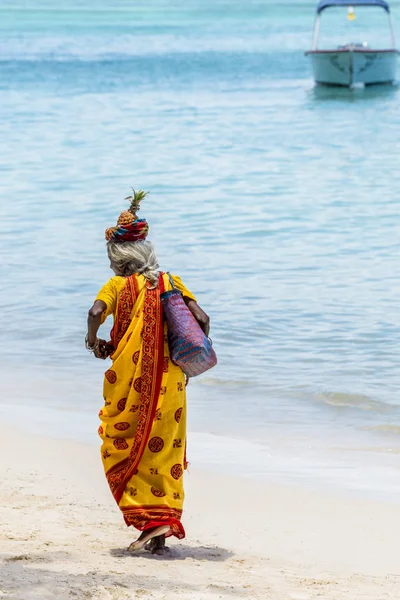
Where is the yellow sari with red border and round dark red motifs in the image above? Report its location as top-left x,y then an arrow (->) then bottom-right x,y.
96,274 -> 195,539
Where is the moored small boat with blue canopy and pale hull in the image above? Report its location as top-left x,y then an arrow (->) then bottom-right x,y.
306,0 -> 399,87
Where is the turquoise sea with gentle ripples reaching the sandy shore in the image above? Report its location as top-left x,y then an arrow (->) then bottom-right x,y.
0,0 -> 400,494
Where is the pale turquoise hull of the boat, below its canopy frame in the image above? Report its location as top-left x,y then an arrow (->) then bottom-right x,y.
307,48 -> 398,87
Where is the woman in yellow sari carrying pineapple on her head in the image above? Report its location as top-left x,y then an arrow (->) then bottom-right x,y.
86,191 -> 209,554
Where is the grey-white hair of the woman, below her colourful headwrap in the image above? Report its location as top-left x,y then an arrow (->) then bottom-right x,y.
107,241 -> 159,287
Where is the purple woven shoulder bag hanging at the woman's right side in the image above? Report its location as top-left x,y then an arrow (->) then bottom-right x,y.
161,273 -> 217,377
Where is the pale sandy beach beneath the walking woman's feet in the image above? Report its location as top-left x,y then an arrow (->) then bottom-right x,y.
0,426 -> 400,600
